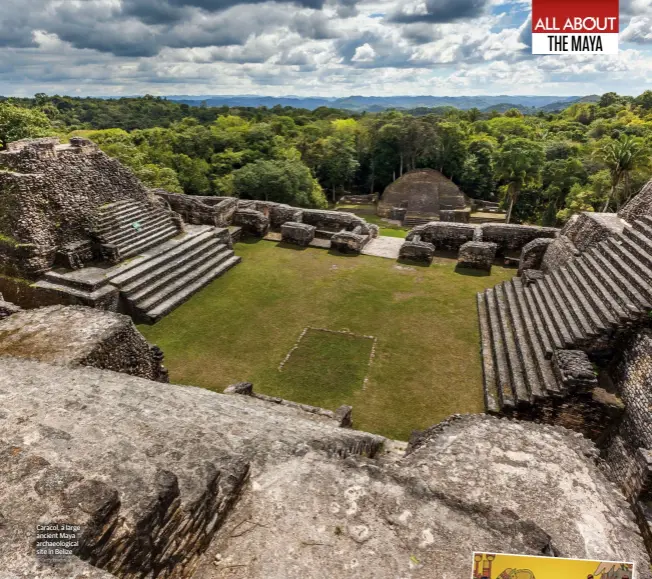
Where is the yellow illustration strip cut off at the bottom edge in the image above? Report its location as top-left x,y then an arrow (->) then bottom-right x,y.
472,553 -> 634,579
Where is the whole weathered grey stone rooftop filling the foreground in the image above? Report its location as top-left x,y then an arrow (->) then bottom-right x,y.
0,357 -> 650,579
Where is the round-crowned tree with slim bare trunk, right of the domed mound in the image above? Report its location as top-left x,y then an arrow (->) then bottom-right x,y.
496,137 -> 545,223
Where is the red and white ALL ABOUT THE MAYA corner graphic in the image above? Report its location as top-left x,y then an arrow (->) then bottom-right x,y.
532,0 -> 620,54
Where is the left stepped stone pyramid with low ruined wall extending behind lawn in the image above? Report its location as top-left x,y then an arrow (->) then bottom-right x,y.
0,137 -> 378,323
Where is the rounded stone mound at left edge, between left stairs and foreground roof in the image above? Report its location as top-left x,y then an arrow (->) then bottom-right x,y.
0,306 -> 167,381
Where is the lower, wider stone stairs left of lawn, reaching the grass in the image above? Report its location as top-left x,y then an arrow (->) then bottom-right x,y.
109,227 -> 241,324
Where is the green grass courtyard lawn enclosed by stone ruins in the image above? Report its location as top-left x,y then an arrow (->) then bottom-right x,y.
140,241 -> 515,439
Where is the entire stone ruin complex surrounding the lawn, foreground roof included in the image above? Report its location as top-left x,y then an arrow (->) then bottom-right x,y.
0,139 -> 652,579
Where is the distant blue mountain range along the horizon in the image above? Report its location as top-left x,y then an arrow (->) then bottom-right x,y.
166,95 -> 600,114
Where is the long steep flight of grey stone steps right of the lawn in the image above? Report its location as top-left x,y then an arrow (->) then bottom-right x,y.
477,216 -> 652,413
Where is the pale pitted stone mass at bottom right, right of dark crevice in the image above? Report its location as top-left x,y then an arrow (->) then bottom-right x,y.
197,418 -> 647,579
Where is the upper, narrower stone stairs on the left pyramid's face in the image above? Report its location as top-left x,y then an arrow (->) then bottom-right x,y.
92,199 -> 180,262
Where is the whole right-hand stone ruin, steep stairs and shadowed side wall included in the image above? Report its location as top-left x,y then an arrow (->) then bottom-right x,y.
478,184 -> 652,552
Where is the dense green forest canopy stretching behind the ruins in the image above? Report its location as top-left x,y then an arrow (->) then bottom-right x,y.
0,91 -> 652,225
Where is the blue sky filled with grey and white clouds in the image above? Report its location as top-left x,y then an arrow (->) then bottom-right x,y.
0,0 -> 652,97
